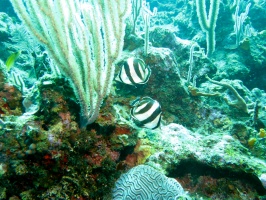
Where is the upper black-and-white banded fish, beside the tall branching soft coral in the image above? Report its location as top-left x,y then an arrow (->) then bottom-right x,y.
115,57 -> 151,85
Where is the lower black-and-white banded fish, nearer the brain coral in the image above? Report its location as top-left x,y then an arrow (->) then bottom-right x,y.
130,97 -> 162,129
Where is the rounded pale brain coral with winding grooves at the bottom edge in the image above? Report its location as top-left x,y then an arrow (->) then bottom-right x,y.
113,165 -> 185,200
